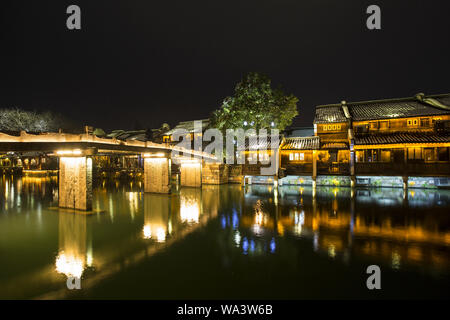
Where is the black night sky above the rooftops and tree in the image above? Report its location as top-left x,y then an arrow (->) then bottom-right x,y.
0,0 -> 450,130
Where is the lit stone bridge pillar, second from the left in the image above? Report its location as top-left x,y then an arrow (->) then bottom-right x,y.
144,157 -> 170,193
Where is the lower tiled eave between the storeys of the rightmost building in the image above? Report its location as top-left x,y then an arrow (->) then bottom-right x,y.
355,132 -> 450,145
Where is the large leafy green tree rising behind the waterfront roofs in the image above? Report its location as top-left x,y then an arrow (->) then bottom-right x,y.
211,73 -> 298,131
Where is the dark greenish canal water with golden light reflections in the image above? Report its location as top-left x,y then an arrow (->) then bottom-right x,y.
0,176 -> 450,299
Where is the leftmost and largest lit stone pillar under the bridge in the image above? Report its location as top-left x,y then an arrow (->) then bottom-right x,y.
59,157 -> 92,211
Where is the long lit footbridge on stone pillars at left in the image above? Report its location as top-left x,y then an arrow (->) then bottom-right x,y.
0,132 -> 217,210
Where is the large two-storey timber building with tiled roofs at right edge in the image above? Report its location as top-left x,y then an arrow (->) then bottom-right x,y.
349,95 -> 450,180
